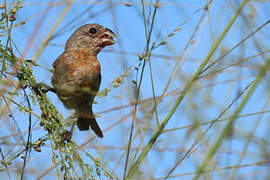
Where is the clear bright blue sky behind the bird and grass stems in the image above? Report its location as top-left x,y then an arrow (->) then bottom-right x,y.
0,0 -> 270,179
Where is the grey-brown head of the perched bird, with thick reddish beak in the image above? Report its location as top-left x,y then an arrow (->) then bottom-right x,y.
65,24 -> 115,54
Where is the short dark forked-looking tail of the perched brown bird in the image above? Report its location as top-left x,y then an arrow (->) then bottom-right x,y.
77,110 -> 103,138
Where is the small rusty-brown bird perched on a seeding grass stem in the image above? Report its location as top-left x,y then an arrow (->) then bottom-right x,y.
52,24 -> 116,138
